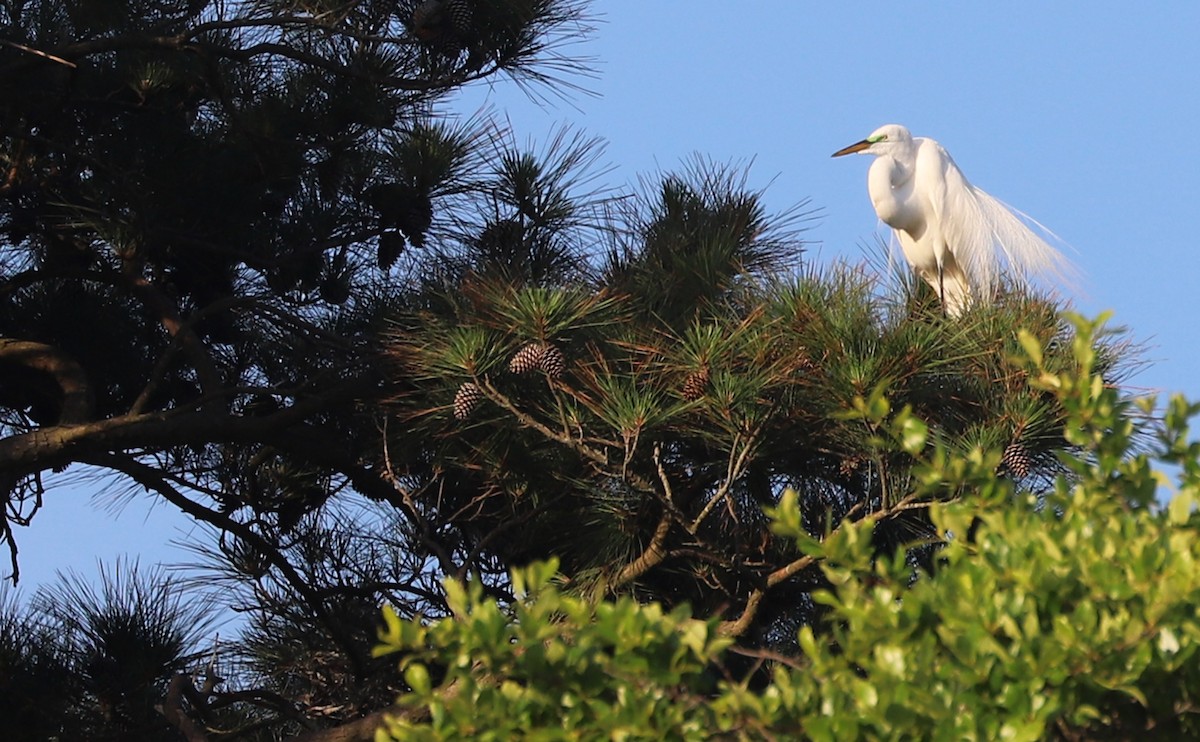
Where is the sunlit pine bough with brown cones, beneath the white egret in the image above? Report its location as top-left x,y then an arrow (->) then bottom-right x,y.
389,163 -> 1129,652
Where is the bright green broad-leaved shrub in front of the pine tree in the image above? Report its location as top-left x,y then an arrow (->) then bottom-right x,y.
380,319 -> 1200,740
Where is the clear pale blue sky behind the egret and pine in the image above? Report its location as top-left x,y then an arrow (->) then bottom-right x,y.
9,0 -> 1200,594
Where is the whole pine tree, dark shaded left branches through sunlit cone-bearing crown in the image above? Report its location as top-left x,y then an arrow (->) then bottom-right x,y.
0,0 -> 1142,740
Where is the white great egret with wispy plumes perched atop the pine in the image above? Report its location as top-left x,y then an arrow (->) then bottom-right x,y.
833,124 -> 1074,317
